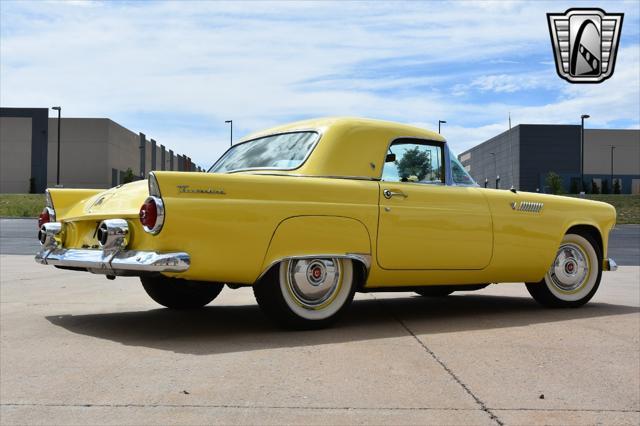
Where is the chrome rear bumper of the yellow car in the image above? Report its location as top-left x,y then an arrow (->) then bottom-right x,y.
35,247 -> 191,275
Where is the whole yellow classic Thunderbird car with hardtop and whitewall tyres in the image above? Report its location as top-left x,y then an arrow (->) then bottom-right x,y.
36,118 -> 616,328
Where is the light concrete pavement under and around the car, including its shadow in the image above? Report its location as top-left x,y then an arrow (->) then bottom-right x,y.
0,220 -> 640,425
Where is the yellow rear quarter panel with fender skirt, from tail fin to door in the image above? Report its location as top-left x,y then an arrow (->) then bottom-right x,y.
153,172 -> 378,284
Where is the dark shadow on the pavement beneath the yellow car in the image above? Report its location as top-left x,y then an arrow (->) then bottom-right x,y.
46,295 -> 640,355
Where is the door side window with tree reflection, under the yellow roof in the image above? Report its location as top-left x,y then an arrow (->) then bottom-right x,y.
382,139 -> 444,184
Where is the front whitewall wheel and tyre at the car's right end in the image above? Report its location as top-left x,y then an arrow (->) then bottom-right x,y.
527,234 -> 602,308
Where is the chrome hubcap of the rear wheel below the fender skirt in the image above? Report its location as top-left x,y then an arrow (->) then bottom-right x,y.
287,259 -> 340,309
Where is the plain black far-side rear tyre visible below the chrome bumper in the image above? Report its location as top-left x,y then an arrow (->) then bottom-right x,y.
140,275 -> 224,309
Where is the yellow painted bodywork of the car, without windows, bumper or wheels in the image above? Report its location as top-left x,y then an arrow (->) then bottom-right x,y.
45,118 -> 615,287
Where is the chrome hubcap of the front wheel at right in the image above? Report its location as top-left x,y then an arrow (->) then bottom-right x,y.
549,243 -> 589,291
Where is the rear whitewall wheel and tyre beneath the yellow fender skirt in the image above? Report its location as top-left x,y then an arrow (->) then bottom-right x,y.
253,258 -> 356,329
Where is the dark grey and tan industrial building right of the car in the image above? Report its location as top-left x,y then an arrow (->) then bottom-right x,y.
458,124 -> 640,194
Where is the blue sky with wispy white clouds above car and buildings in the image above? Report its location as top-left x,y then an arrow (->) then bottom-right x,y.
0,0 -> 640,167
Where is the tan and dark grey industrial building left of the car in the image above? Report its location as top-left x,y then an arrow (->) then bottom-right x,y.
0,108 -> 202,193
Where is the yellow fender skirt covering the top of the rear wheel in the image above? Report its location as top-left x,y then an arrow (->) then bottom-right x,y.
256,216 -> 371,279
